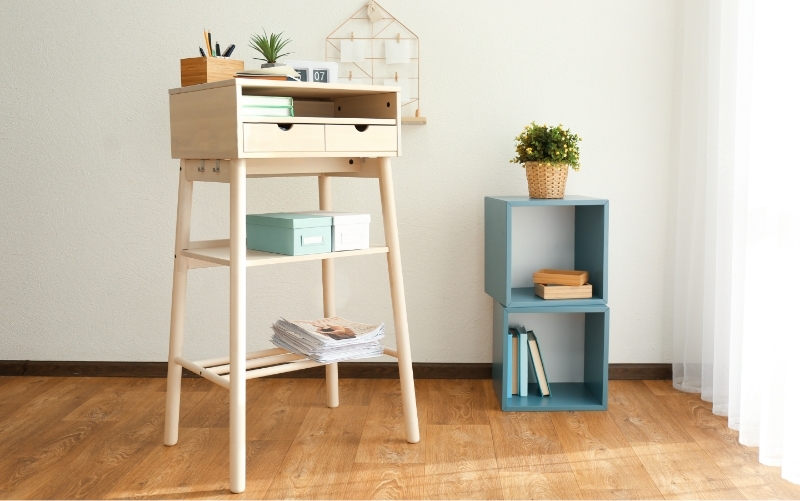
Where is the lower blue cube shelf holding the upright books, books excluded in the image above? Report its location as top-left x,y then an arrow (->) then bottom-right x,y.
492,301 -> 609,411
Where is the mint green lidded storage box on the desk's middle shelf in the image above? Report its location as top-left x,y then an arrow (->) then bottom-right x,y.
246,212 -> 333,256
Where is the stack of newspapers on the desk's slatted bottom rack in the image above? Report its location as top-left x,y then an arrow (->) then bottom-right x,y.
272,317 -> 385,364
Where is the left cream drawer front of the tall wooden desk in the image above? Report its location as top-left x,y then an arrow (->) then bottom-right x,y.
243,123 -> 325,153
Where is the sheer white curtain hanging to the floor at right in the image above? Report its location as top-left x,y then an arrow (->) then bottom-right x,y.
673,0 -> 800,483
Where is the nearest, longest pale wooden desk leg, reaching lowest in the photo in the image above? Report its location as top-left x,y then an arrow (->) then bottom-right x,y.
230,160 -> 247,493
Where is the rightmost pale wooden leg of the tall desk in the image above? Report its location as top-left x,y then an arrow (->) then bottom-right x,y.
378,157 -> 419,444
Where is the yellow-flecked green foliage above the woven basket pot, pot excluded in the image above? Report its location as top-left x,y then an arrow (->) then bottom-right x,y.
511,122 -> 581,171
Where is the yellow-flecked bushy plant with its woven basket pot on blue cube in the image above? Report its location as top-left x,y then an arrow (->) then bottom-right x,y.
511,122 -> 581,198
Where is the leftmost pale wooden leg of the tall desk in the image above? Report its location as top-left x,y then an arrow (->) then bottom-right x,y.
164,160 -> 192,445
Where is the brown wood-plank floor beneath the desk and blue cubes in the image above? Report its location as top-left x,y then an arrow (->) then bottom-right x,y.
0,377 -> 800,499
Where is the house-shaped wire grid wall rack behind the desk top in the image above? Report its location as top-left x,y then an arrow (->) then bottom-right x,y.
325,1 -> 426,124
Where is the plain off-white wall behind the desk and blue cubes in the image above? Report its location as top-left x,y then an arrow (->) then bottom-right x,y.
0,0 -> 679,363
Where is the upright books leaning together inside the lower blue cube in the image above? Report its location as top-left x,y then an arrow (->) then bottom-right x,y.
508,327 -> 552,397
